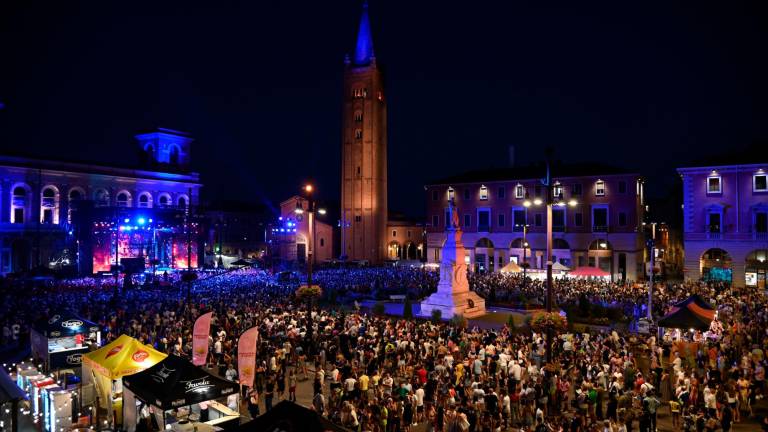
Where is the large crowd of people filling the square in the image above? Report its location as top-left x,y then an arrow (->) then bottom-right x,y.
0,268 -> 768,432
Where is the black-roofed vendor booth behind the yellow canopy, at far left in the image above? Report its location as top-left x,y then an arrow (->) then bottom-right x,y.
30,315 -> 101,373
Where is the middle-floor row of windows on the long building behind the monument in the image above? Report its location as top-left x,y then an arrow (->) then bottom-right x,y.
432,206 -> 628,232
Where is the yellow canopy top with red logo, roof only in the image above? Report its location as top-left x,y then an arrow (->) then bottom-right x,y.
83,335 -> 167,380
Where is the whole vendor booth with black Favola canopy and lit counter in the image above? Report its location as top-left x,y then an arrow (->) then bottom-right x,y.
123,355 -> 240,432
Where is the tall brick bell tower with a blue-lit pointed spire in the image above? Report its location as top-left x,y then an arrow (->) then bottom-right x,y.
341,4 -> 387,263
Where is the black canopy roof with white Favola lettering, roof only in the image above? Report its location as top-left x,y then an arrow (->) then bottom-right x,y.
123,355 -> 238,410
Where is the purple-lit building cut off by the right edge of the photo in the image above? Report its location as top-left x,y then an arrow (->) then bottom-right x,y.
677,163 -> 768,288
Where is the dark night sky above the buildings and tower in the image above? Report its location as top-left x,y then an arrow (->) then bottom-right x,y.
0,0 -> 768,216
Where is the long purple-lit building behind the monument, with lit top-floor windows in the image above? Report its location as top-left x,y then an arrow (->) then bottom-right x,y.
425,165 -> 645,280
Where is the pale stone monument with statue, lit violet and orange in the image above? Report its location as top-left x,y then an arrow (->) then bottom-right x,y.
421,200 -> 485,318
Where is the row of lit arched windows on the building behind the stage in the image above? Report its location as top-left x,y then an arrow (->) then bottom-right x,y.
10,184 -> 189,224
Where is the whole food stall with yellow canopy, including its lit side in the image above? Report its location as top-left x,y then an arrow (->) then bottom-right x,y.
83,335 -> 167,425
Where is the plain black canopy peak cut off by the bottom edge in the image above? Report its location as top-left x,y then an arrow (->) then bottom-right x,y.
237,400 -> 349,432
